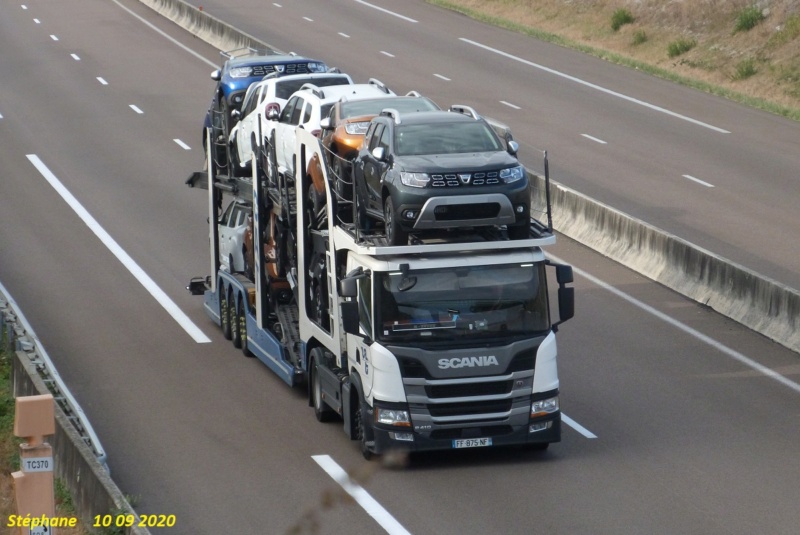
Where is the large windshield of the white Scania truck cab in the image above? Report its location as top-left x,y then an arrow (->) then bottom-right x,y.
375,263 -> 550,343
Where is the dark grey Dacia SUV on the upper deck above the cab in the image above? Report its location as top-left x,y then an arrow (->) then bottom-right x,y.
353,105 -> 530,245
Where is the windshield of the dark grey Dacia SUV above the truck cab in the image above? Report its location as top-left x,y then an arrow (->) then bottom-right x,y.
395,121 -> 503,156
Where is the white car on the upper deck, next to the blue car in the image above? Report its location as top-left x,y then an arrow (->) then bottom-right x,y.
228,72 -> 353,175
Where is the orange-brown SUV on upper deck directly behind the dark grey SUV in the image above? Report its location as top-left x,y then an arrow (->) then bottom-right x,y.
320,95 -> 441,187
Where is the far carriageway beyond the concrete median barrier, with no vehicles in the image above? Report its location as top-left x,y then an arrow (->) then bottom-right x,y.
189,0 -> 800,288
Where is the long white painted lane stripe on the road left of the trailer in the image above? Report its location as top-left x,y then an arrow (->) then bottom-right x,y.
27,154 -> 211,344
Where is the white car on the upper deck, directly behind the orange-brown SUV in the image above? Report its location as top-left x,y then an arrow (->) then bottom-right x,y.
262,78 -> 395,180
